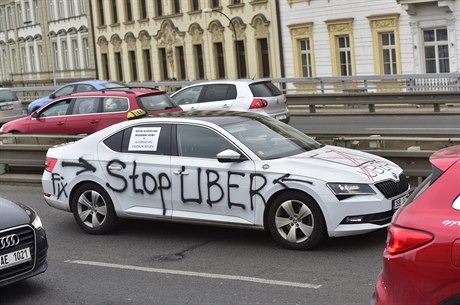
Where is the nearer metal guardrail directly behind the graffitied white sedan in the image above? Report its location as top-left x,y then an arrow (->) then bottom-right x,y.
0,134 -> 460,185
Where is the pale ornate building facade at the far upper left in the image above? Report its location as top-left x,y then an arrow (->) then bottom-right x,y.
0,0 -> 96,87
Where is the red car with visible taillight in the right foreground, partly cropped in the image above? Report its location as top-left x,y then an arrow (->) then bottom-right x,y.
374,146 -> 460,305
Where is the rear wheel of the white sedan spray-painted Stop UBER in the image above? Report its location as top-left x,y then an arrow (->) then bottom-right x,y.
71,183 -> 118,234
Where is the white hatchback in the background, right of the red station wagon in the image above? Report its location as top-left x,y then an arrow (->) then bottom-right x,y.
171,80 -> 290,123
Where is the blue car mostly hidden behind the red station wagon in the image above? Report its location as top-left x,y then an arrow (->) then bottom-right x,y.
27,80 -> 127,114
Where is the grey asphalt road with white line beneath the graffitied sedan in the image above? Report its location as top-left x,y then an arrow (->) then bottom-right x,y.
0,185 -> 386,305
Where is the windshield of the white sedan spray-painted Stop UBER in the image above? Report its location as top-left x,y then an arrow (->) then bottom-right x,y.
222,118 -> 321,160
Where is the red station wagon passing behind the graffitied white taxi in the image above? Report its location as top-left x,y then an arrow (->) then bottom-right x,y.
0,88 -> 182,134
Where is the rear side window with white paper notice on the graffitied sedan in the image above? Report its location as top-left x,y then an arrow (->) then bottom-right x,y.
122,124 -> 171,155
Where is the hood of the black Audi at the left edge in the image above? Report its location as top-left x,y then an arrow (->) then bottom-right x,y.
0,198 -> 33,230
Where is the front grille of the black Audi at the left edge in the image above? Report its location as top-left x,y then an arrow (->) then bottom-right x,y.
0,226 -> 35,281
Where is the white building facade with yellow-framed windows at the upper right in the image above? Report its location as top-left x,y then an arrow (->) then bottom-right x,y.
280,0 -> 460,77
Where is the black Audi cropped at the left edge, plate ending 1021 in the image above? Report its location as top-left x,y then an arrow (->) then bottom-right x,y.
0,198 -> 48,287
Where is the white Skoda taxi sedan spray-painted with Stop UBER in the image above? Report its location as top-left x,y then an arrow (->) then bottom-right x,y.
42,111 -> 409,249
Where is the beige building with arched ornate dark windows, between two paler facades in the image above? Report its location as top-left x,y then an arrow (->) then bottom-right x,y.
91,0 -> 282,82
